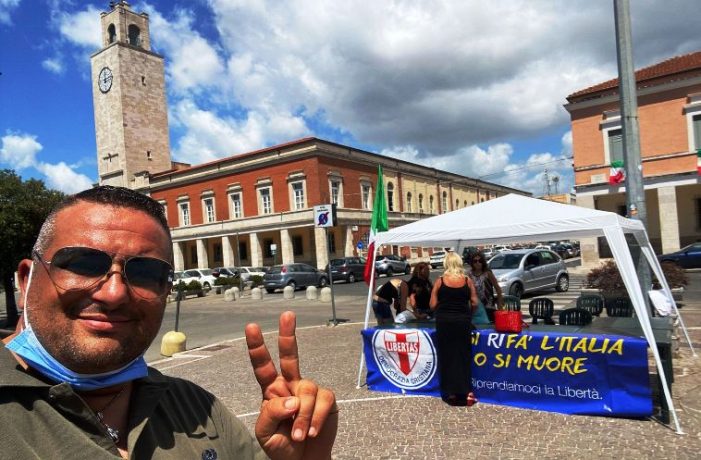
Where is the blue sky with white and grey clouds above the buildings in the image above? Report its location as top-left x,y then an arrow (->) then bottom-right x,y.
0,0 -> 701,196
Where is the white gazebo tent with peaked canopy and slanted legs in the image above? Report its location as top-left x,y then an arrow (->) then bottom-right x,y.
358,194 -> 696,433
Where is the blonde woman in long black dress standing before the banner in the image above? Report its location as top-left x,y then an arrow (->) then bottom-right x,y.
430,252 -> 478,406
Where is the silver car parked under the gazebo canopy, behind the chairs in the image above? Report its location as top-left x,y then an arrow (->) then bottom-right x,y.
489,249 -> 570,297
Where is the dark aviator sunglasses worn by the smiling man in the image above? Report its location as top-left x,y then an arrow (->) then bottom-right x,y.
34,246 -> 173,299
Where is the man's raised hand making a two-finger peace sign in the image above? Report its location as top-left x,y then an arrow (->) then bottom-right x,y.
246,311 -> 338,460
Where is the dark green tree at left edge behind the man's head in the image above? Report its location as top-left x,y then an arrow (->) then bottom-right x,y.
0,169 -> 64,327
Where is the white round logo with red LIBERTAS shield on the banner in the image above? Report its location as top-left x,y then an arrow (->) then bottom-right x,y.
372,329 -> 436,390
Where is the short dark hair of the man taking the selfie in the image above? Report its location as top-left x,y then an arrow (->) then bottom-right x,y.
34,185 -> 170,254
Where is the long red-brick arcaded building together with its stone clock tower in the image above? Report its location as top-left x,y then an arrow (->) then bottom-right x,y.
91,2 -> 524,270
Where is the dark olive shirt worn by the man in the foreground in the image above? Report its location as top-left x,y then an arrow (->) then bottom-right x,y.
0,344 -> 267,460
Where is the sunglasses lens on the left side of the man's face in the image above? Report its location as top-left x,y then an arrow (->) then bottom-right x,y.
51,247 -> 112,289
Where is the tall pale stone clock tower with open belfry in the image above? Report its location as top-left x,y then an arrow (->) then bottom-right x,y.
90,1 -> 171,188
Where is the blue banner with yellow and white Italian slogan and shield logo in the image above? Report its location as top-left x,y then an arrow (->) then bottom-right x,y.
362,329 -> 652,417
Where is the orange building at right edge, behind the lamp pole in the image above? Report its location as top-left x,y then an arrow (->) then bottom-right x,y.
565,51 -> 701,264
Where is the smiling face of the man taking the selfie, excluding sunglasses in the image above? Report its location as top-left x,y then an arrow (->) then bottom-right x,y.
20,202 -> 170,374
